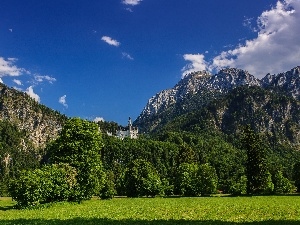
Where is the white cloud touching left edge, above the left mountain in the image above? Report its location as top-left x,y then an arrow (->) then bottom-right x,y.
0,57 -> 26,77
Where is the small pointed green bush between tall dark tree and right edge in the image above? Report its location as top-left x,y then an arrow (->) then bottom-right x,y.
273,171 -> 296,194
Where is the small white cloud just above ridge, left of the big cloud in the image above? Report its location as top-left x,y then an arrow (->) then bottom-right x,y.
181,54 -> 208,77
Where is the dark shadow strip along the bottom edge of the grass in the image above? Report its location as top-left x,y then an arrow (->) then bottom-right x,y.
0,218 -> 300,225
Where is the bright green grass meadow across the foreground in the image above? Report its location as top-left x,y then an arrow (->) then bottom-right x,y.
0,196 -> 300,225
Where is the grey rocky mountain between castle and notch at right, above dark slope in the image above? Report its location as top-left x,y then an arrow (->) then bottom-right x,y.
134,68 -> 261,132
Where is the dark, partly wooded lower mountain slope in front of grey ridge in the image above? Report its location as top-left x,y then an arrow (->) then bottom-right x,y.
160,86 -> 300,146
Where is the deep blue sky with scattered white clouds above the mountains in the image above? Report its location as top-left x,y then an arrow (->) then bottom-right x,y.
0,0 -> 300,125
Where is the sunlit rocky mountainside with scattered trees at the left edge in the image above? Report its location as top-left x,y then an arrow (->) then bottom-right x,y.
0,83 -> 67,148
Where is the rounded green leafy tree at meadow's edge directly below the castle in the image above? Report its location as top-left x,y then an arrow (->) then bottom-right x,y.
125,159 -> 162,197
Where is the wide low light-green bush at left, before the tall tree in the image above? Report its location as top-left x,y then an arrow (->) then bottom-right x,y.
9,164 -> 77,208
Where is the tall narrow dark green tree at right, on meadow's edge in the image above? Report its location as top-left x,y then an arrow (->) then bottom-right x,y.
241,125 -> 274,194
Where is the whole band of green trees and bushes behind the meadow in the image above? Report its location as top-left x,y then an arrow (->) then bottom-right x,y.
2,118 -> 300,208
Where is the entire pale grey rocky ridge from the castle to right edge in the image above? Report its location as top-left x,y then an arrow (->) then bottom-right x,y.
134,67 -> 300,132
